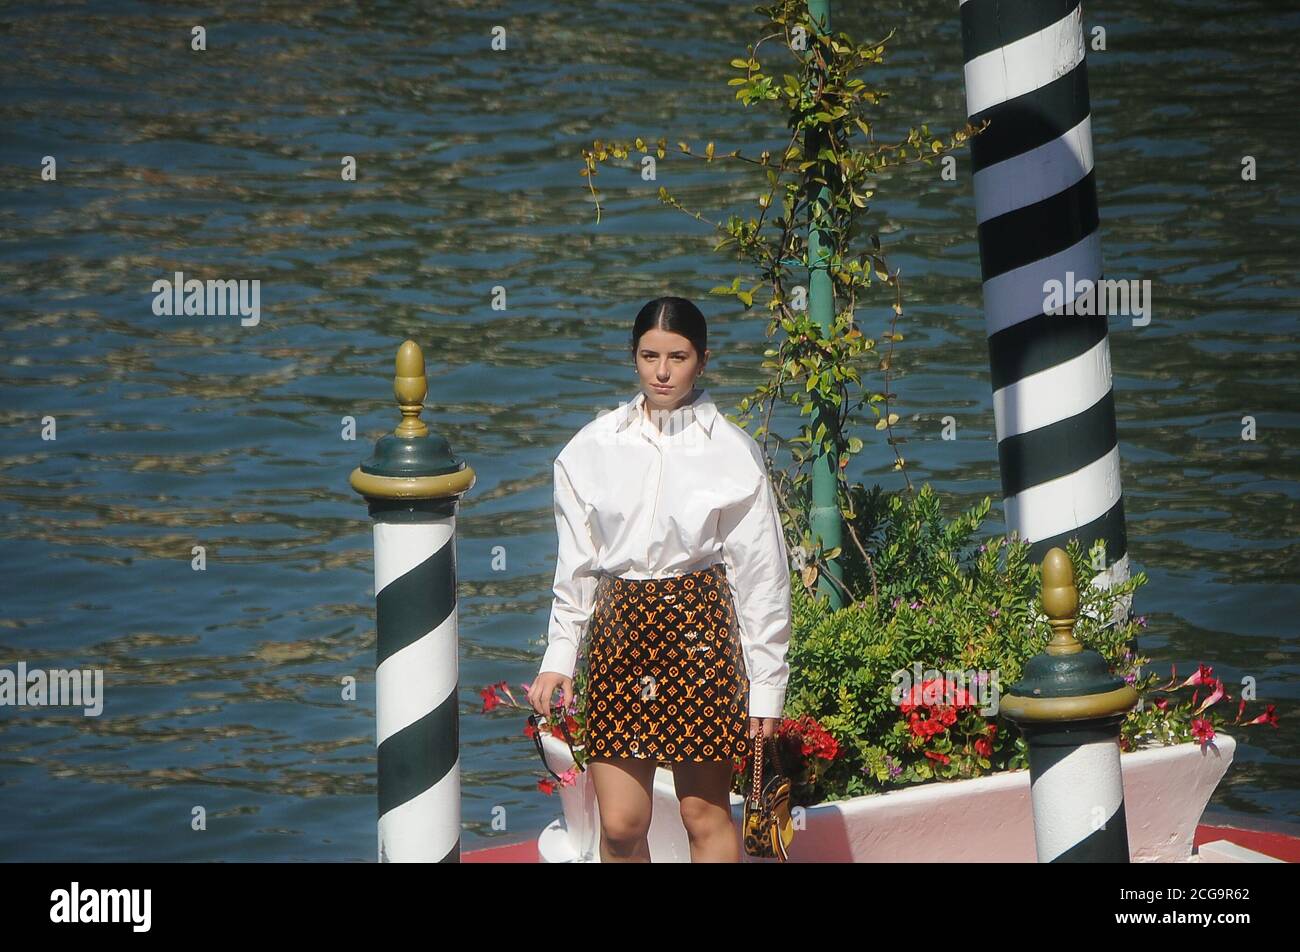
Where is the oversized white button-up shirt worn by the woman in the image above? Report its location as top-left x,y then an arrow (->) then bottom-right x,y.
538,390 -> 790,718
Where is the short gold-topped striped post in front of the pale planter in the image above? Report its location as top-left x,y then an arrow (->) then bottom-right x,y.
1000,549 -> 1138,862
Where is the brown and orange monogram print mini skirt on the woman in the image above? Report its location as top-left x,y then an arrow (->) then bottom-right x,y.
584,562 -> 750,763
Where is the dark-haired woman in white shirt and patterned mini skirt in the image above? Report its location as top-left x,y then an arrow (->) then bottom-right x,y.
528,298 -> 790,862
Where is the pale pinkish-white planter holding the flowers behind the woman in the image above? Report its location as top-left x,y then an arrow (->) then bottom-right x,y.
538,734 -> 1236,862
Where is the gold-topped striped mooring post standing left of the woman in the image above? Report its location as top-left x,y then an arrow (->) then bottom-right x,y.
350,341 -> 475,862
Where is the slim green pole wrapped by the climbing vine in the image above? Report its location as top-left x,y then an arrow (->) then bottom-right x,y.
803,0 -> 844,609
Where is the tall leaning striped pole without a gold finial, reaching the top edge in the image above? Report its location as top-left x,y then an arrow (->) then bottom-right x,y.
961,0 -> 1131,622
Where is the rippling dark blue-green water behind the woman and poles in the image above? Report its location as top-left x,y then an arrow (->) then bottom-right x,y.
0,0 -> 1300,861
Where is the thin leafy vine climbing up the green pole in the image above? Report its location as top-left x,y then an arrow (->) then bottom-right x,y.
580,0 -> 980,602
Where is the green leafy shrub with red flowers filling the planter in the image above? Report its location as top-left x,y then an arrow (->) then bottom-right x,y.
769,485 -> 1277,804
